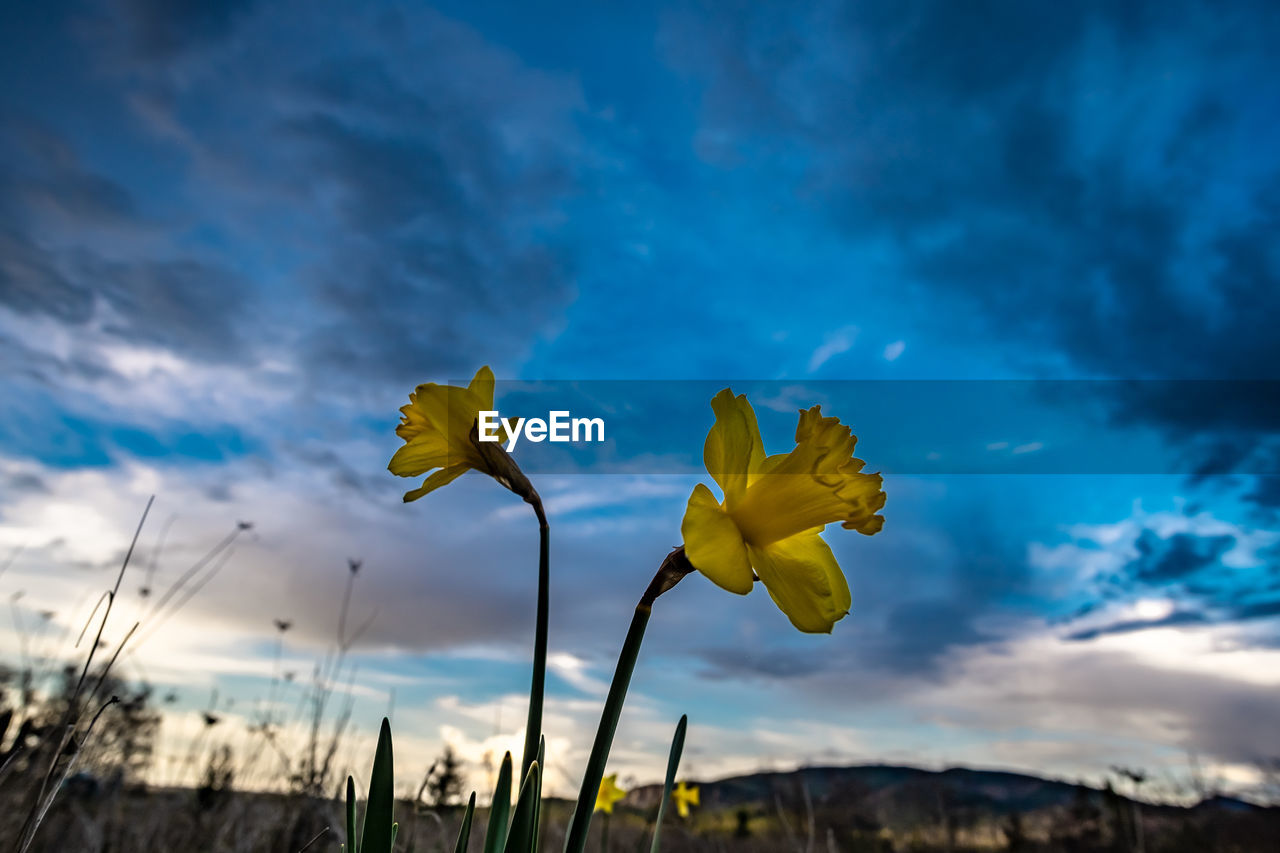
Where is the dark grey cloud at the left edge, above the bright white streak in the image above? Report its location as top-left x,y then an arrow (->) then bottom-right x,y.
0,120 -> 250,361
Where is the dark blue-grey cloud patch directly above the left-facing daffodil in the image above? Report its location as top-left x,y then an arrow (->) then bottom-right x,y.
282,63 -> 573,382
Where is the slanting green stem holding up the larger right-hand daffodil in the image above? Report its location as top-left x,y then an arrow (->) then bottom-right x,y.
564,547 -> 694,853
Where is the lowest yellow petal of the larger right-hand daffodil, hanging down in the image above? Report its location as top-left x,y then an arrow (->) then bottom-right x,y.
747,530 -> 852,634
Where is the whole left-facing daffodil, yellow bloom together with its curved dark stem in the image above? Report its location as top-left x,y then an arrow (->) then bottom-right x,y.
387,365 -> 550,779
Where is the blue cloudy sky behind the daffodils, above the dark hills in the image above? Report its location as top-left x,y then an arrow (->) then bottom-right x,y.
0,0 -> 1280,790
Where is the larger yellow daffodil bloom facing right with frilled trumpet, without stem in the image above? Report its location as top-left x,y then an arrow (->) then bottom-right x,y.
680,388 -> 884,633
